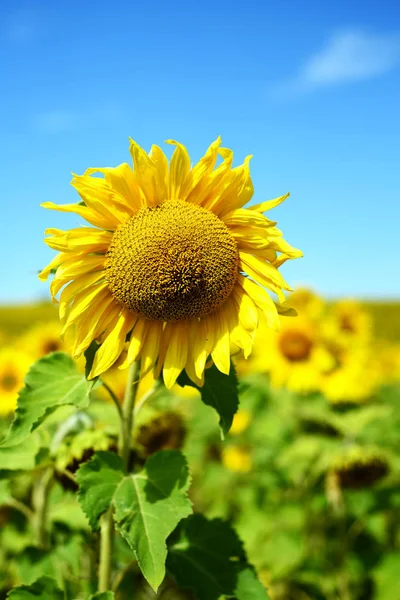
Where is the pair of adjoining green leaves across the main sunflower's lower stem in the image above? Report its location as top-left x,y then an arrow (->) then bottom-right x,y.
77,450 -> 192,589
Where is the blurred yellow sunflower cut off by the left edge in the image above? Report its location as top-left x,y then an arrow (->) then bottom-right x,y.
0,348 -> 31,415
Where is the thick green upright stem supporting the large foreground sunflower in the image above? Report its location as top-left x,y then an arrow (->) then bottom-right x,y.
99,362 -> 140,592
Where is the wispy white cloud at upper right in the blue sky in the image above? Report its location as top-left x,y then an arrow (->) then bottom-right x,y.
274,29 -> 400,95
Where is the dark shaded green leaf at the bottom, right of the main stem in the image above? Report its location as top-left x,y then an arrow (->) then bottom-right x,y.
167,514 -> 268,600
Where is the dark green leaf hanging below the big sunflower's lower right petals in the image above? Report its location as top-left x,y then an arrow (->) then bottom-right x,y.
178,363 -> 239,438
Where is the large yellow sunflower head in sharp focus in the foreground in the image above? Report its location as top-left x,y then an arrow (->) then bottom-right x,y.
39,138 -> 301,388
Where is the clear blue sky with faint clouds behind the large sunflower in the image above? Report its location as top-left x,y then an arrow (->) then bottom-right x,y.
0,0 -> 400,302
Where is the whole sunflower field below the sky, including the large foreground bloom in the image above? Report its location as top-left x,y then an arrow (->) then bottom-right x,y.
0,139 -> 400,600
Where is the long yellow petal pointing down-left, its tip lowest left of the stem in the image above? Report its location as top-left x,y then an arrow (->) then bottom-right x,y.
88,310 -> 134,379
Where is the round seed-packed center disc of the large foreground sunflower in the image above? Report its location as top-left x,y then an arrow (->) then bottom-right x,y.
106,200 -> 239,321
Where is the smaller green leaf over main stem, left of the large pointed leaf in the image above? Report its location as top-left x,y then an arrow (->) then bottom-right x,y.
76,451 -> 125,530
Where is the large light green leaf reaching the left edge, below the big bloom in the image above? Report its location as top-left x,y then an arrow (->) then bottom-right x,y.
0,352 -> 94,454
